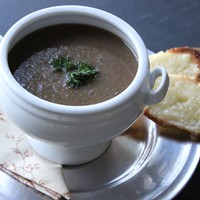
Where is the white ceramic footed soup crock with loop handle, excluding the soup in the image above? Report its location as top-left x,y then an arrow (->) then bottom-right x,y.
0,6 -> 169,165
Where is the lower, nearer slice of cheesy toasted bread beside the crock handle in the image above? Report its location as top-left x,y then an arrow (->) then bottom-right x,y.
144,75 -> 200,136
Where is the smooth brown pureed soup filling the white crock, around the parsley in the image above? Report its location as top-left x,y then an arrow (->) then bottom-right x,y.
8,24 -> 138,105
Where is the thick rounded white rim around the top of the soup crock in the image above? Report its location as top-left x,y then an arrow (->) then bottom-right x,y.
0,5 -> 149,115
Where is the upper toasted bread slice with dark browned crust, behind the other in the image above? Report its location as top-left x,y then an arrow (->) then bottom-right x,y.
149,47 -> 200,82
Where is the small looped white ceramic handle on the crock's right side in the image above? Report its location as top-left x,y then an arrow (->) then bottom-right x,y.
145,67 -> 169,105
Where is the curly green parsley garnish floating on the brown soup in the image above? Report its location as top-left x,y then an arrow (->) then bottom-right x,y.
50,56 -> 99,87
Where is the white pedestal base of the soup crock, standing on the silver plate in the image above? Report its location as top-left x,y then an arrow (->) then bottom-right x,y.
27,136 -> 111,165
